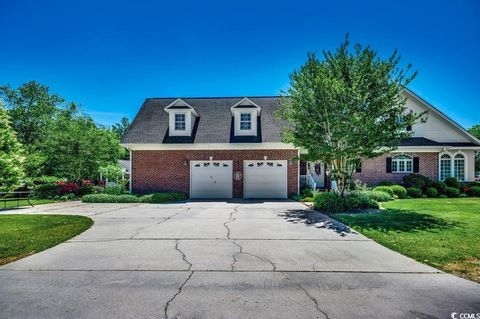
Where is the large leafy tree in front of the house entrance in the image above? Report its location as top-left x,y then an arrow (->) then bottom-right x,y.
278,36 -> 423,195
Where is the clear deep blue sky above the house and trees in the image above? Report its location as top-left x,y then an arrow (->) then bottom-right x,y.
0,0 -> 480,127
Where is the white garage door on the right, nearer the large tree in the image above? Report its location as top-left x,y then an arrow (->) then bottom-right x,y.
244,161 -> 287,198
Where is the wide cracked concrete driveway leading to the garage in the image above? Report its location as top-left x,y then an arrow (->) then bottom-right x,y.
0,201 -> 480,319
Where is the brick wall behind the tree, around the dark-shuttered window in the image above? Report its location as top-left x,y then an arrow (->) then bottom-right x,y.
354,153 -> 438,185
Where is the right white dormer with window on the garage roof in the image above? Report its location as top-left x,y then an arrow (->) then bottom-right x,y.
231,97 -> 261,136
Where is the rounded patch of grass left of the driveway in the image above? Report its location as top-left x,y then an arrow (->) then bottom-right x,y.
0,214 -> 93,265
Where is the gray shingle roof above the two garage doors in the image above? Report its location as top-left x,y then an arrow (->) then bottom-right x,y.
122,96 -> 285,144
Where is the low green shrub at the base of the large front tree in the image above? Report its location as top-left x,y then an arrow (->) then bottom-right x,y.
313,192 -> 379,214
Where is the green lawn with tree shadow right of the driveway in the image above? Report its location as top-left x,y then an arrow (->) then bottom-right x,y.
333,198 -> 480,282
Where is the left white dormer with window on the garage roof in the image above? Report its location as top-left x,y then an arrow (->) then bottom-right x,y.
164,99 -> 199,136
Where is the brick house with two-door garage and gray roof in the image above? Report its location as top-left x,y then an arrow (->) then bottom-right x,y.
122,90 -> 480,198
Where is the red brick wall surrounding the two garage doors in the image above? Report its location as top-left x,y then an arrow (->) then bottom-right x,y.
132,149 -> 298,197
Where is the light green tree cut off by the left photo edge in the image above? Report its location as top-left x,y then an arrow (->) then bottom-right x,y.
0,101 -> 24,191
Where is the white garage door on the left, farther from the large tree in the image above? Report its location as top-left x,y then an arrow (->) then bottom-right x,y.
190,161 -> 233,198
